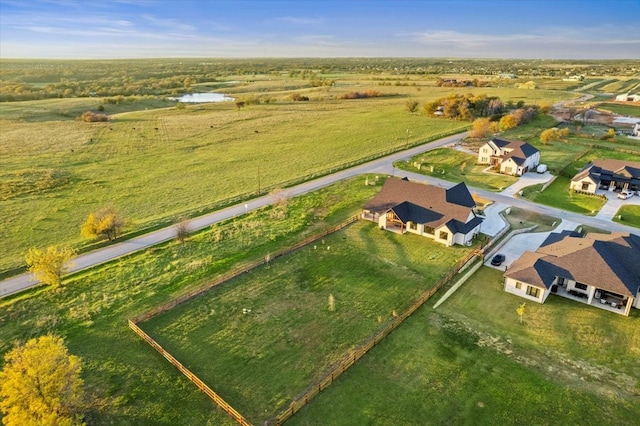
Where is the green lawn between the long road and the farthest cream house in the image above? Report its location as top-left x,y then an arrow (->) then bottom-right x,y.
395,148 -> 518,191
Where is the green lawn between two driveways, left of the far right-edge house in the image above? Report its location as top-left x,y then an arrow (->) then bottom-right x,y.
522,176 -> 605,216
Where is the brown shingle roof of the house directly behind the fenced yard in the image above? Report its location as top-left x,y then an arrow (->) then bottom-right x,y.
363,178 -> 482,231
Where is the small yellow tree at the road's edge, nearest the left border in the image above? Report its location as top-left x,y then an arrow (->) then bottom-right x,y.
25,246 -> 76,288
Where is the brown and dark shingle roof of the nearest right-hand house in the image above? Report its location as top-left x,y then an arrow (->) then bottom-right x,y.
504,233 -> 640,297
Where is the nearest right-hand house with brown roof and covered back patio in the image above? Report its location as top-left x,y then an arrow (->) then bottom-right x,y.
504,232 -> 640,316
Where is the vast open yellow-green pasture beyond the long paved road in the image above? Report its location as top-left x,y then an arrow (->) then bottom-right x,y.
0,74 -> 575,272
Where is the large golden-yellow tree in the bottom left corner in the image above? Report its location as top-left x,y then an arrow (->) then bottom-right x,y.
0,335 -> 84,426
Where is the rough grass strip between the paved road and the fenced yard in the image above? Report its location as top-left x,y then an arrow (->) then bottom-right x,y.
0,178 -> 380,425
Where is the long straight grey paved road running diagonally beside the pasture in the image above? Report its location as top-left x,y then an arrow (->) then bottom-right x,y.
0,133 -> 466,298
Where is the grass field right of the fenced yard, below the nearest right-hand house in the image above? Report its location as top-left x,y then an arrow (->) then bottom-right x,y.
290,268 -> 640,425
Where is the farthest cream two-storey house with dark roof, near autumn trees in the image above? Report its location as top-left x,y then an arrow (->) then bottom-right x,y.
478,138 -> 540,176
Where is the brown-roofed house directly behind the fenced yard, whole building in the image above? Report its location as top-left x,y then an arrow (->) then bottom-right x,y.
362,178 -> 482,246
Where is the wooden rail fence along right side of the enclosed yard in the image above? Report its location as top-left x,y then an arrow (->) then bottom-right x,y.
268,249 -> 482,425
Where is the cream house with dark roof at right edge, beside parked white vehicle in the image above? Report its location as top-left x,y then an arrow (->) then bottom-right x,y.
569,159 -> 640,194
